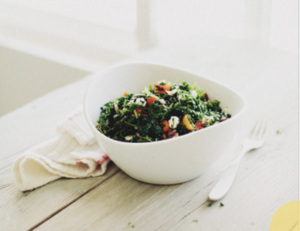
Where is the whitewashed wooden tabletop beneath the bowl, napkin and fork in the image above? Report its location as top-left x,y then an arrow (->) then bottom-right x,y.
0,35 -> 299,231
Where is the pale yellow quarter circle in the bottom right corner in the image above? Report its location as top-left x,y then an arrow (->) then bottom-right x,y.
270,201 -> 300,231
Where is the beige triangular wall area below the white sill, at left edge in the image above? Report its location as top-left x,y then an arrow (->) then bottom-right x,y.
0,46 -> 89,116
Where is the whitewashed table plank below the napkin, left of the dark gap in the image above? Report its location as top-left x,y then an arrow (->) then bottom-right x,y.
0,153 -> 119,231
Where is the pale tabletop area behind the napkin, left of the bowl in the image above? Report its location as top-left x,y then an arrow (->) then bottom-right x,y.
0,76 -> 93,158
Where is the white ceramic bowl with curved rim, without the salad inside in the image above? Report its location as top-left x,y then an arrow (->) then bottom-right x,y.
84,63 -> 246,184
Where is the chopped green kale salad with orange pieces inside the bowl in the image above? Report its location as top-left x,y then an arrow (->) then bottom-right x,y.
96,80 -> 231,142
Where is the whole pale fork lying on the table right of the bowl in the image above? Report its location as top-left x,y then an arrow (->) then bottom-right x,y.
208,120 -> 267,201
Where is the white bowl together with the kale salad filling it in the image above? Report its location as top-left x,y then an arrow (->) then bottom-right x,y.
84,63 -> 247,184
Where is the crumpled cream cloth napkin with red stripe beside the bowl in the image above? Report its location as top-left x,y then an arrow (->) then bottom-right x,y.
13,107 -> 110,191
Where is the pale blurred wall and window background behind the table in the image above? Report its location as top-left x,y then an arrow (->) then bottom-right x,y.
0,0 -> 299,116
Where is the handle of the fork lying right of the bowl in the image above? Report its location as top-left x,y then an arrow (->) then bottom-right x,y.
208,149 -> 249,201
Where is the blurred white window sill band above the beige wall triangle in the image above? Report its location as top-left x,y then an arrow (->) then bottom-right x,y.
0,1 -> 131,72
